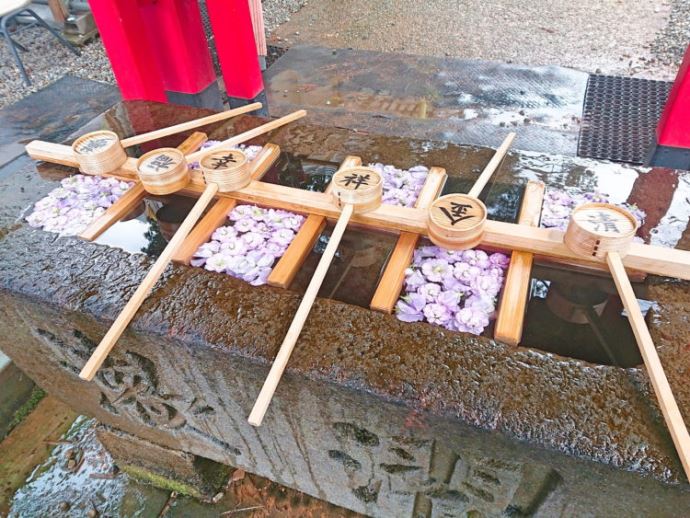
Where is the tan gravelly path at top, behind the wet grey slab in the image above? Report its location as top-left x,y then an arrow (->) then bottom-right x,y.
270,0 -> 690,79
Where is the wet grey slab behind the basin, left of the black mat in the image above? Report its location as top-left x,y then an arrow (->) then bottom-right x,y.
266,46 -> 588,155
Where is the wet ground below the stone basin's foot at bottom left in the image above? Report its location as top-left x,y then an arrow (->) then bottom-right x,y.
6,416 -> 358,518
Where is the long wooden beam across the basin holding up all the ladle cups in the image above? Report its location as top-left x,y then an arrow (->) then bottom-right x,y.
21,141 -> 690,280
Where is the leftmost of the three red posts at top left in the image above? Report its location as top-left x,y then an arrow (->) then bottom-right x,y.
89,0 -> 168,102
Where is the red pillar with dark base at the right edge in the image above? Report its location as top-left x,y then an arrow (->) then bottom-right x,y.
649,46 -> 690,169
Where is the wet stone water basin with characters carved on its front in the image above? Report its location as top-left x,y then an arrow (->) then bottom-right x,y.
0,103 -> 690,516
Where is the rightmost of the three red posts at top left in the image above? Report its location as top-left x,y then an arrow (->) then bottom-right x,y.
206,0 -> 264,105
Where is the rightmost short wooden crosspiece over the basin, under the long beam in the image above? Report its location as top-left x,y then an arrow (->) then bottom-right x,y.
494,181 -> 545,346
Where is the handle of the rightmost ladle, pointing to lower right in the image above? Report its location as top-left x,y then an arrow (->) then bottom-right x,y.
606,252 -> 690,480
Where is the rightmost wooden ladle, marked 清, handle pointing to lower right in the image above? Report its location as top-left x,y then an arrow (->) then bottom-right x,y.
563,203 -> 690,480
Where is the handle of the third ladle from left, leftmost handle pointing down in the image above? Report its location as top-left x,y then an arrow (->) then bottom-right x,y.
79,183 -> 218,381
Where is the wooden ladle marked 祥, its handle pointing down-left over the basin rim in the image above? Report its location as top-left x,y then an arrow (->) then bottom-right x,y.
248,167 -> 383,426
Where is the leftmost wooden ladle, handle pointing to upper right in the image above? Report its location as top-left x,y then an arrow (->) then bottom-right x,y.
72,103 -> 262,174
